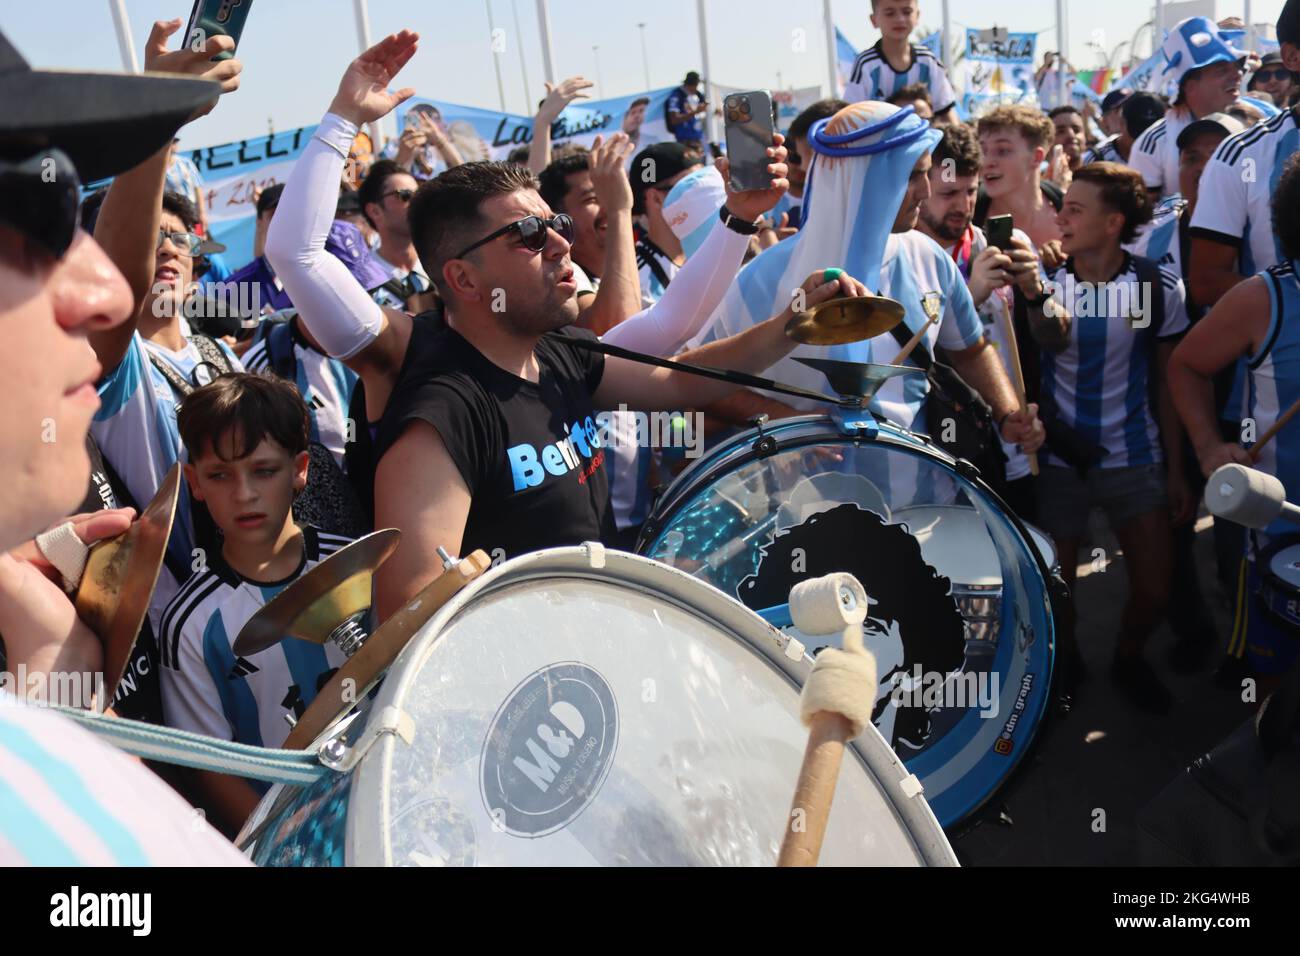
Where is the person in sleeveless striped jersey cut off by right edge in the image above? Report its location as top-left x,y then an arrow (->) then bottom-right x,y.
1170,151 -> 1300,684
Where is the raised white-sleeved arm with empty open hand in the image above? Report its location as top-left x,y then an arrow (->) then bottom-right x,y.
267,30 -> 419,410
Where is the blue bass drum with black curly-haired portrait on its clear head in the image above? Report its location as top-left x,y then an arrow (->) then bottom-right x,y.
637,416 -> 1054,827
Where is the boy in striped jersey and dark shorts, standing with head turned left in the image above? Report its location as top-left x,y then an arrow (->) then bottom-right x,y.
1031,163 -> 1195,713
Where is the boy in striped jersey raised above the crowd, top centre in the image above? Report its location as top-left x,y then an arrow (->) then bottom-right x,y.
844,0 -> 957,125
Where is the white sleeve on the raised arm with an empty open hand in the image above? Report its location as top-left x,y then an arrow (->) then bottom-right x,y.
267,113 -> 384,359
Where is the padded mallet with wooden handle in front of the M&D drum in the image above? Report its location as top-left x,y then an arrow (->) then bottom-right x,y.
776,574 -> 876,866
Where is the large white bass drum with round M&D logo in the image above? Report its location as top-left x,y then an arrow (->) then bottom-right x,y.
241,545 -> 956,866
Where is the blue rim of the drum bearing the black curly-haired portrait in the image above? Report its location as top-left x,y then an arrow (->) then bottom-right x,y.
636,415 -> 1065,834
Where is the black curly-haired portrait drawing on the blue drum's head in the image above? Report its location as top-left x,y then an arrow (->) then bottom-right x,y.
737,505 -> 966,753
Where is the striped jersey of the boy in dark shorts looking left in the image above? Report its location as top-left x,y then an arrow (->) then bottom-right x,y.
1043,255 -> 1188,468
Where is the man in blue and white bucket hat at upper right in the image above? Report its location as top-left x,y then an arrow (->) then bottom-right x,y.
1128,17 -> 1247,200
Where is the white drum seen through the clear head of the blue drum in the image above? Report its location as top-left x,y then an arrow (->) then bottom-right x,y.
894,505 -> 1060,641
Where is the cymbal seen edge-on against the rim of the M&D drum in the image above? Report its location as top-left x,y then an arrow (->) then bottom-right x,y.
281,551 -> 491,750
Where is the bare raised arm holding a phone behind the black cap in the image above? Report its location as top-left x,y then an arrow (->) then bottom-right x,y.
90,20 -> 242,372
